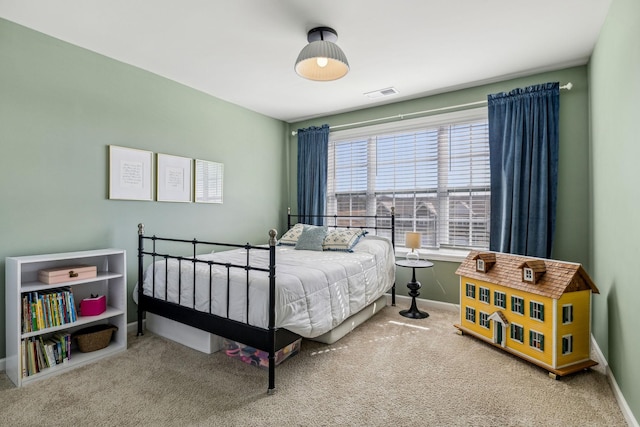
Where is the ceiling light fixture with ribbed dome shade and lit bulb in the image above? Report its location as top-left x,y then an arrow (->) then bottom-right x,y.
295,27 -> 349,81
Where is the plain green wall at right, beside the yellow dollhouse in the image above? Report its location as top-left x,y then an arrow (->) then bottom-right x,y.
589,0 -> 640,420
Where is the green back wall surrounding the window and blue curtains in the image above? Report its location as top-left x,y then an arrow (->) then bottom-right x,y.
289,66 -> 590,304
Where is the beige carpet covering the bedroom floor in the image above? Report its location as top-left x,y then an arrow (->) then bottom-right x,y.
0,307 -> 626,426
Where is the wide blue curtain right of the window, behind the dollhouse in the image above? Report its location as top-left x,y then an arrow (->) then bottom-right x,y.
488,83 -> 560,258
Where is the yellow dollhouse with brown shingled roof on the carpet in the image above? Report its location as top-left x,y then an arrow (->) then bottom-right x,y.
455,251 -> 599,378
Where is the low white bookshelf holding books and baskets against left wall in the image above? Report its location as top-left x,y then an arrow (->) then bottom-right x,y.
5,249 -> 127,387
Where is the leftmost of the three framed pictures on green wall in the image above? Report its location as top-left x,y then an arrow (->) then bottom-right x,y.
109,145 -> 153,200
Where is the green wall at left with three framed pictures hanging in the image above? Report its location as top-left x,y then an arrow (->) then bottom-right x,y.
0,19 -> 287,358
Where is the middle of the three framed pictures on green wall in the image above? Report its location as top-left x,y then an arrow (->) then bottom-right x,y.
157,153 -> 193,202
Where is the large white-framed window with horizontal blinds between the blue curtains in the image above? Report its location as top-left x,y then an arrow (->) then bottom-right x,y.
327,108 -> 490,250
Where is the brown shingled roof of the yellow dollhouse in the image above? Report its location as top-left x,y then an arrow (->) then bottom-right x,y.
456,251 -> 600,299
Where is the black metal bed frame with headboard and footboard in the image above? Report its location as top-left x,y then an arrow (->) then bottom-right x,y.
138,210 -> 395,394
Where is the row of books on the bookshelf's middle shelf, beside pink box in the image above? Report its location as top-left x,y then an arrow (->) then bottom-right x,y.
22,287 -> 78,333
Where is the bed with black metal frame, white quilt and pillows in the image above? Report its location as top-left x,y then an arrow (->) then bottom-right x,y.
135,211 -> 395,393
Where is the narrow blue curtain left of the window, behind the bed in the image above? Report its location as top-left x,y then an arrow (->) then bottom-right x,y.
298,125 -> 329,225
